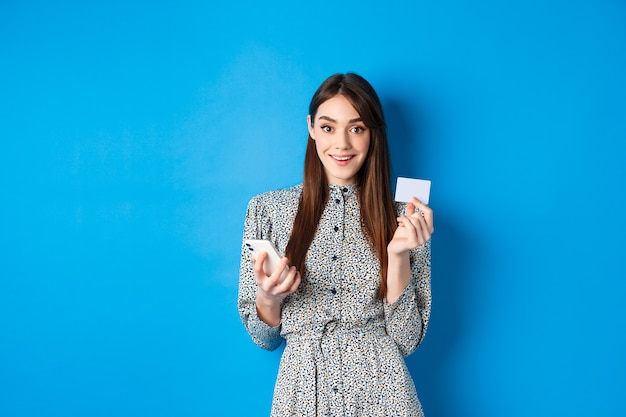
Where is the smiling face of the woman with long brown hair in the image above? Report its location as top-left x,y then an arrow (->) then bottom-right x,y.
307,95 -> 370,185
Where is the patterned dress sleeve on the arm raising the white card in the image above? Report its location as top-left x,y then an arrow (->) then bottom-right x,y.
384,240 -> 432,356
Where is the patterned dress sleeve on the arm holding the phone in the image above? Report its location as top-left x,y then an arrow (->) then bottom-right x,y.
237,196 -> 283,350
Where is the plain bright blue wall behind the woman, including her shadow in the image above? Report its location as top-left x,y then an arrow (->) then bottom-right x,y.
0,0 -> 626,417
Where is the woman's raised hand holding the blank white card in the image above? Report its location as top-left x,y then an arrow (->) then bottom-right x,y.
387,197 -> 435,255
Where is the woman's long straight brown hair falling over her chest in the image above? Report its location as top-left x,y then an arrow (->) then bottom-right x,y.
286,73 -> 397,298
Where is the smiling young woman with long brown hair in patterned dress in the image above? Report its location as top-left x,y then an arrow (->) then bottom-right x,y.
238,74 -> 434,417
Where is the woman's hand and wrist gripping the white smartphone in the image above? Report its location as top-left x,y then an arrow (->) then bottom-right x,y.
252,252 -> 301,327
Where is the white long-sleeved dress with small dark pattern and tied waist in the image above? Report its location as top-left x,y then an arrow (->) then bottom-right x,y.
238,184 -> 431,417
